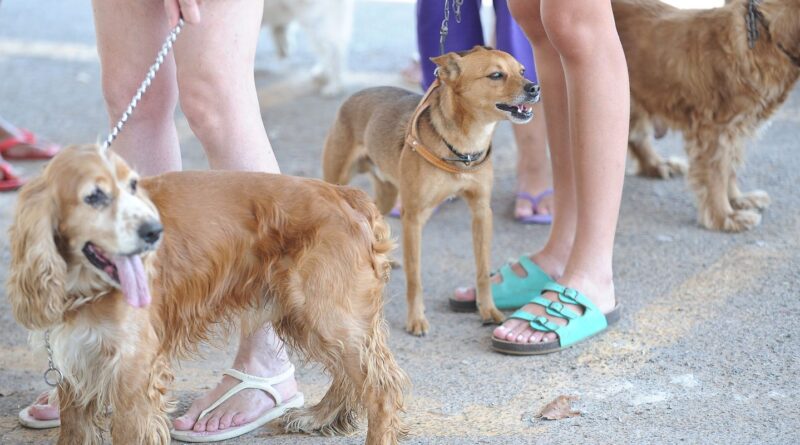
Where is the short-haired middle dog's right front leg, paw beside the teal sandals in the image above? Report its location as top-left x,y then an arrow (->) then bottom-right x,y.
464,191 -> 505,323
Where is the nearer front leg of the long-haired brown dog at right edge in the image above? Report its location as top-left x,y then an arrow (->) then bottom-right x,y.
686,130 -> 761,232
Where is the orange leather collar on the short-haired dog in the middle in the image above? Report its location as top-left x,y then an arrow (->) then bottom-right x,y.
406,78 -> 492,173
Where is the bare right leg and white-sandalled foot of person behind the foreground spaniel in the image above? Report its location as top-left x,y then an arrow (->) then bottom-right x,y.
174,0 -> 297,432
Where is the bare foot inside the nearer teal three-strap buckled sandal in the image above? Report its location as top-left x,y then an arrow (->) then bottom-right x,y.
492,277 -> 616,343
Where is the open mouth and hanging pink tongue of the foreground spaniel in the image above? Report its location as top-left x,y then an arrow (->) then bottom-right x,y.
82,242 -> 152,307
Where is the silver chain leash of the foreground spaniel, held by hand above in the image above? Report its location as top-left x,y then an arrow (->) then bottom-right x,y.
44,18 -> 184,388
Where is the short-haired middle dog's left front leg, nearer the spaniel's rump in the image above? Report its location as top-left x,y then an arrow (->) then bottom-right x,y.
402,206 -> 432,336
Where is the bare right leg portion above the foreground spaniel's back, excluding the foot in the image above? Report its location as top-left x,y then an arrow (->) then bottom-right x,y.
175,0 -> 279,173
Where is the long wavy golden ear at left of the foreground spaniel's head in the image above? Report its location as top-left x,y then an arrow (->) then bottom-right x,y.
7,177 -> 67,330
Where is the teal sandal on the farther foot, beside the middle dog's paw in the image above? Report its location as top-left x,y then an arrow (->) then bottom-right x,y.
450,255 -> 553,312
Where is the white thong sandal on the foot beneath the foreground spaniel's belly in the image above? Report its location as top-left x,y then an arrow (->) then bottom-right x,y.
170,365 -> 304,442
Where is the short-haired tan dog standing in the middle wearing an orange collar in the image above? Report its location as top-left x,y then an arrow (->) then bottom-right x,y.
323,46 -> 539,335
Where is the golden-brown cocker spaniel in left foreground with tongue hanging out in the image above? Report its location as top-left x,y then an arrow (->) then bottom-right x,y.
8,146 -> 407,444
